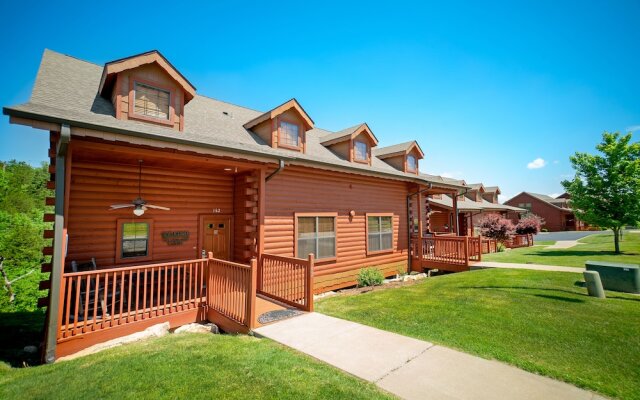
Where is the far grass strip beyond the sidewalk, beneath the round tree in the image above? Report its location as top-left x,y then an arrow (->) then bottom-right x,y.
482,233 -> 640,268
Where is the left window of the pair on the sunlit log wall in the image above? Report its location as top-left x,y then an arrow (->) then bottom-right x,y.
296,217 -> 336,259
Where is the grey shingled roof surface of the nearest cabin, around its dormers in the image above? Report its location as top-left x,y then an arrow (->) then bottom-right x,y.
4,50 -> 462,189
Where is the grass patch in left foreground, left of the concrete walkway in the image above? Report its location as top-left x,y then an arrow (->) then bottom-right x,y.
0,334 -> 391,399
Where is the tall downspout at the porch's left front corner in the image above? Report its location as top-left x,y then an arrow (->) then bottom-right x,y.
44,125 -> 71,363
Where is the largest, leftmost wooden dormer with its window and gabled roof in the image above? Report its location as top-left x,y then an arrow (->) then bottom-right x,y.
99,50 -> 196,131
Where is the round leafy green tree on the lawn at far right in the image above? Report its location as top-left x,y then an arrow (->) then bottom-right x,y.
562,132 -> 640,253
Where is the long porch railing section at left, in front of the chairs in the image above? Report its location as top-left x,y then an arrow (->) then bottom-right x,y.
58,259 -> 208,340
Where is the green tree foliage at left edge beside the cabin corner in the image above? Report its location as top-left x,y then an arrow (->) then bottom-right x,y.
0,160 -> 51,312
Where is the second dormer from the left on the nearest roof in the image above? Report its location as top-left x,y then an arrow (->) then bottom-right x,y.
243,99 -> 313,153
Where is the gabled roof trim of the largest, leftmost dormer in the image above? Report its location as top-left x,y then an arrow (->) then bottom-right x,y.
98,50 -> 196,104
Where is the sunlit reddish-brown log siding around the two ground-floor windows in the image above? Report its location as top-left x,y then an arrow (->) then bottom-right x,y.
264,166 -> 408,293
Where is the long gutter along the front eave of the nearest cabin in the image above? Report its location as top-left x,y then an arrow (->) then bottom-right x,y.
2,107 -> 468,190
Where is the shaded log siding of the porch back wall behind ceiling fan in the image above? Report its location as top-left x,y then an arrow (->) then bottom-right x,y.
66,157 -> 233,268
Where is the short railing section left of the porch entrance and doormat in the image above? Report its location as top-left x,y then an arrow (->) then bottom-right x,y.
207,254 -> 257,330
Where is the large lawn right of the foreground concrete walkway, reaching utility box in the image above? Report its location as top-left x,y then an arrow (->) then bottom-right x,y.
316,270 -> 640,400
